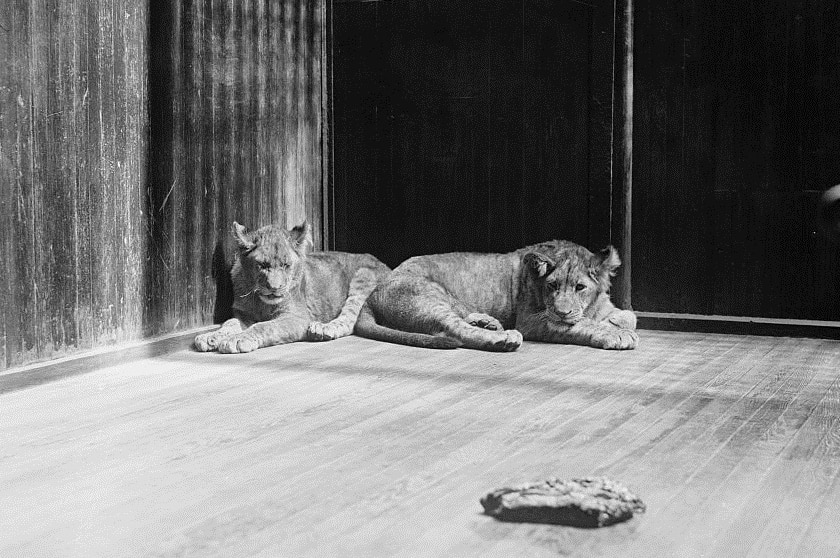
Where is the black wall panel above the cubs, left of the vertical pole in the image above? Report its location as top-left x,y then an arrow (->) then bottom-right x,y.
333,0 -> 614,272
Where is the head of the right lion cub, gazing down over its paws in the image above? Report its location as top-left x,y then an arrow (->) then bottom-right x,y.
522,241 -> 621,325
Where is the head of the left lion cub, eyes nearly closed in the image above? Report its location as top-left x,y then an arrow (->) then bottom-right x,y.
231,221 -> 312,306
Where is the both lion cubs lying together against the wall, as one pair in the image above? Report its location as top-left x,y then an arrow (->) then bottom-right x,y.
195,222 -> 639,353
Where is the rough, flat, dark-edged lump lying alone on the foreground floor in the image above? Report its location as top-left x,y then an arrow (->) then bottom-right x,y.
481,477 -> 645,527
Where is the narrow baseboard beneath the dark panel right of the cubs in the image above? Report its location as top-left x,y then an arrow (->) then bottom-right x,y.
636,312 -> 840,339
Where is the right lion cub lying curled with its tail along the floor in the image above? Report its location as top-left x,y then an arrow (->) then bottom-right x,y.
356,240 -> 638,351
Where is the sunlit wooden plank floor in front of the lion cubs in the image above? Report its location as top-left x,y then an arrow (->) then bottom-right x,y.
0,331 -> 840,557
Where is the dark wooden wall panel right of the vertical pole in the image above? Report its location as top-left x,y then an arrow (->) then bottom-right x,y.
633,0 -> 840,320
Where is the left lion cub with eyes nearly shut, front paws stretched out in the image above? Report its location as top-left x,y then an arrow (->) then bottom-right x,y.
194,223 -> 389,353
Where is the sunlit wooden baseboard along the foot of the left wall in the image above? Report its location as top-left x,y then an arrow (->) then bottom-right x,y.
0,326 -> 212,394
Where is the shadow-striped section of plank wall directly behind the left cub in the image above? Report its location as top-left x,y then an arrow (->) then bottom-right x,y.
145,0 -> 326,333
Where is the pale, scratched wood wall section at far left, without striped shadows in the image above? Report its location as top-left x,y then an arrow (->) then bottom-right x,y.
0,0 -> 148,369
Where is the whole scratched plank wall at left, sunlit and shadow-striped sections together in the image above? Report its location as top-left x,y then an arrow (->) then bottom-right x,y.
0,0 -> 326,370
